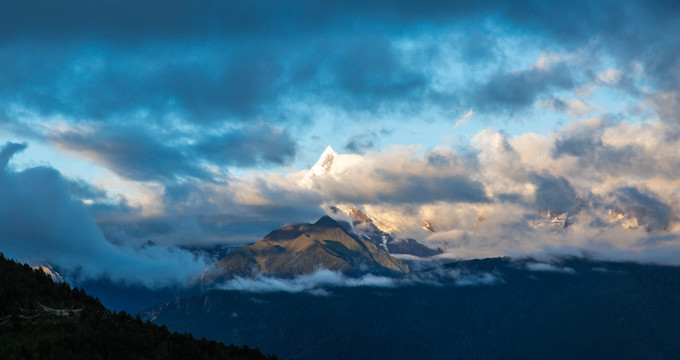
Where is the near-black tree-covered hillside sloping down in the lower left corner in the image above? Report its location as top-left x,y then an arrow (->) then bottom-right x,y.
0,254 -> 275,360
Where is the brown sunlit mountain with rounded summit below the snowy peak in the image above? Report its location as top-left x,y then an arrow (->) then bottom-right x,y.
204,216 -> 408,280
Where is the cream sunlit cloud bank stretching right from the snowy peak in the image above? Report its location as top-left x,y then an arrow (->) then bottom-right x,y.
216,118 -> 680,265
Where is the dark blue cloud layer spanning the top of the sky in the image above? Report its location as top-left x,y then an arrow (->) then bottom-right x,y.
0,0 -> 680,123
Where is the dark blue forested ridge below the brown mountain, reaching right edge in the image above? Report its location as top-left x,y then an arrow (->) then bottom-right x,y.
142,259 -> 680,360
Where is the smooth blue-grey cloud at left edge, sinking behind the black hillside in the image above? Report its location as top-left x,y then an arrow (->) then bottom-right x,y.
0,143 -> 206,287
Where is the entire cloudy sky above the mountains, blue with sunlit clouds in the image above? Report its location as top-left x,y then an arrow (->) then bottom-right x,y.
0,0 -> 680,285
